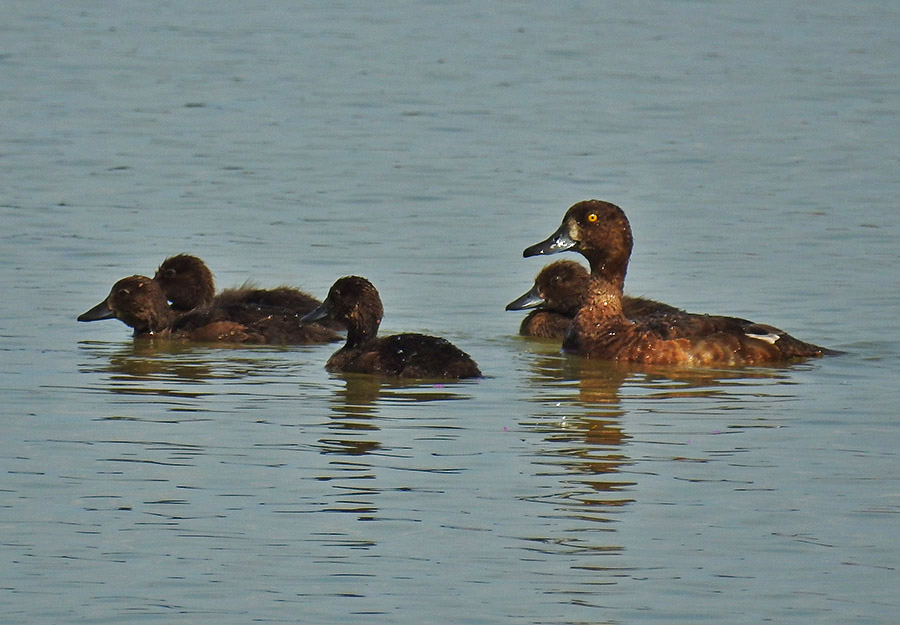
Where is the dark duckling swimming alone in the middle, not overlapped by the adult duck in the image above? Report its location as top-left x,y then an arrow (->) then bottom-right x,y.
303,276 -> 481,379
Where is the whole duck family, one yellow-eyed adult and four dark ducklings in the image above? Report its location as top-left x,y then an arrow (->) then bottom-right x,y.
78,200 -> 832,379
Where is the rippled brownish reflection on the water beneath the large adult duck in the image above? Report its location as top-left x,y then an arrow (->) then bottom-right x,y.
522,343 -> 787,523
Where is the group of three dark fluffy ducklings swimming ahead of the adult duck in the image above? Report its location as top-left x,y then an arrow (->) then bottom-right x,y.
78,254 -> 481,379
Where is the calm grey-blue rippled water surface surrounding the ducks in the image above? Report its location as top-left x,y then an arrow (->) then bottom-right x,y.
0,0 -> 900,625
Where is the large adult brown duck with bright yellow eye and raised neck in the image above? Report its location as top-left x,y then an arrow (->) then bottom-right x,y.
523,200 -> 833,365
